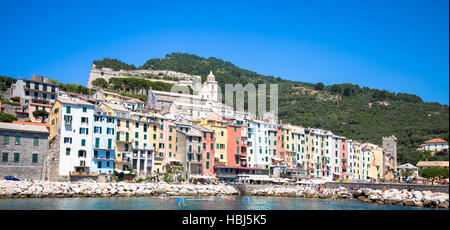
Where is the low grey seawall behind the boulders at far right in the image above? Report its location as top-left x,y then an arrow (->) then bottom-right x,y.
324,182 -> 449,193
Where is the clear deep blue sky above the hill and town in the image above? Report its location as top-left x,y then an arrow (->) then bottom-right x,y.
0,0 -> 449,104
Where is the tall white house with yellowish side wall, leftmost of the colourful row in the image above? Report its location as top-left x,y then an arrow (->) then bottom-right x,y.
46,97 -> 94,180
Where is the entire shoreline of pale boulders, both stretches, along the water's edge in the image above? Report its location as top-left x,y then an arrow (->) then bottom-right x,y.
0,181 -> 449,209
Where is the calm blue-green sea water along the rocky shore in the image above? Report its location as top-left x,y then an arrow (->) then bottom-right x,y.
0,196 -> 440,210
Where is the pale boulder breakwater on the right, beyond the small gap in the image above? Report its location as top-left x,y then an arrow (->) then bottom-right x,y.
249,186 -> 449,209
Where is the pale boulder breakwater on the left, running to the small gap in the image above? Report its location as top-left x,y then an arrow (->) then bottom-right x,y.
0,181 -> 239,198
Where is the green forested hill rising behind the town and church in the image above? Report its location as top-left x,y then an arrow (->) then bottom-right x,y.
94,53 -> 449,164
